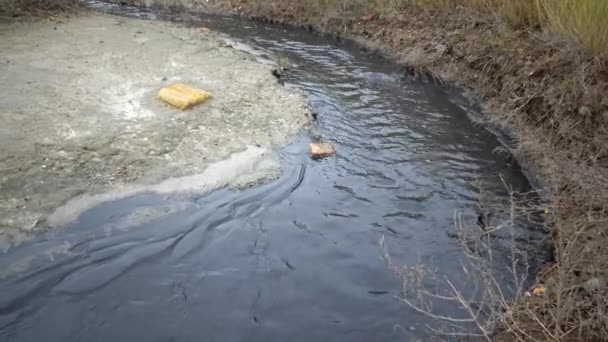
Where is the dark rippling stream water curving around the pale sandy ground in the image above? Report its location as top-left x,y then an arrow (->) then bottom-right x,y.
0,4 -> 542,342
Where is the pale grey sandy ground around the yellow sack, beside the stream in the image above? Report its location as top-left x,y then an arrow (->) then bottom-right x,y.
0,14 -> 310,246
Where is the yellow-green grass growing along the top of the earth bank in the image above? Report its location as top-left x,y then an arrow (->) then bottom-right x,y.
254,0 -> 608,56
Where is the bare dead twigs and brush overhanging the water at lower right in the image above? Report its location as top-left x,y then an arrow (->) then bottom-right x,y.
380,176 -> 608,342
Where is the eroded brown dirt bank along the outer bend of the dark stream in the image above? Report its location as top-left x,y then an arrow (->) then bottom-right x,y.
115,0 -> 608,340
